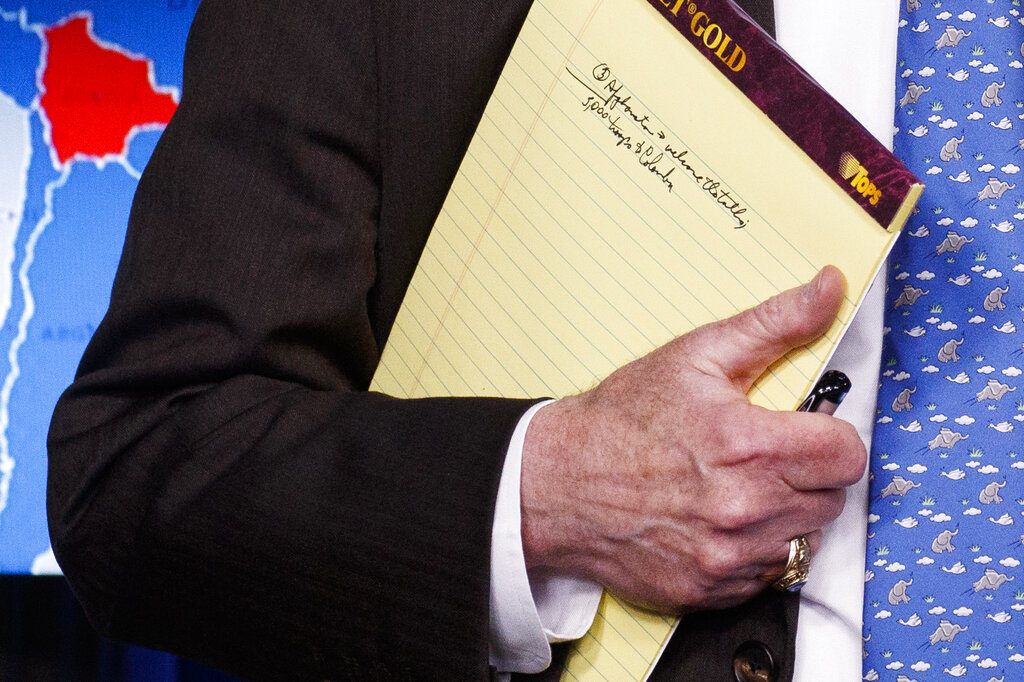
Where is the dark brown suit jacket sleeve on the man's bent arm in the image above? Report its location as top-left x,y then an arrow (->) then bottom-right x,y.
41,0 -> 528,679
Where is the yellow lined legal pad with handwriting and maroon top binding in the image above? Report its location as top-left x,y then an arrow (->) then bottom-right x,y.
372,0 -> 921,680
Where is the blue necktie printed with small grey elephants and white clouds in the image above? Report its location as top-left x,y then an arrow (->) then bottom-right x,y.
863,5 -> 1024,682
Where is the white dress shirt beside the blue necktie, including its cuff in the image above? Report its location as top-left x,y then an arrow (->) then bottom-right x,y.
490,0 -> 899,682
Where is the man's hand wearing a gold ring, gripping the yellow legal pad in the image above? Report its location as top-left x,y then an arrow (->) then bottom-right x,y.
521,267 -> 866,610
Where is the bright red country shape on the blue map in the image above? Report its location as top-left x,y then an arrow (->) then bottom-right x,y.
41,16 -> 177,163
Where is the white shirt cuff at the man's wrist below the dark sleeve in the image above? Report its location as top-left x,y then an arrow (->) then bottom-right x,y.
490,400 -> 601,673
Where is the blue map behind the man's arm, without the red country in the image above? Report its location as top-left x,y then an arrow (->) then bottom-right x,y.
0,0 -> 198,573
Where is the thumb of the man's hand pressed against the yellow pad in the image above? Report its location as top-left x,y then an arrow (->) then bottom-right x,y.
693,265 -> 846,392
